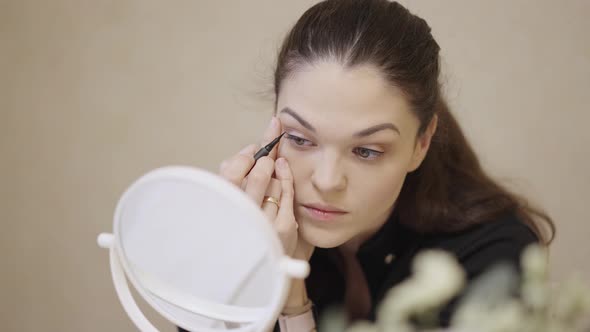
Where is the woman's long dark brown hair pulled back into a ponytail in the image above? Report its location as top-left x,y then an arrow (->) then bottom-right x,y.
274,0 -> 555,244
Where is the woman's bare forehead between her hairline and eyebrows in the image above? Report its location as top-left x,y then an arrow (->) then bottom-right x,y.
277,62 -> 416,135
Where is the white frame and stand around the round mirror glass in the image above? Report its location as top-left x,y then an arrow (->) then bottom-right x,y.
97,166 -> 309,332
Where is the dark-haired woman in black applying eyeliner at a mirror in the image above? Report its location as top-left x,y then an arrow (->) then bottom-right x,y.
220,0 -> 555,331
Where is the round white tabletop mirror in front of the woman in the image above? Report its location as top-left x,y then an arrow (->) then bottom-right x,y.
98,167 -> 309,331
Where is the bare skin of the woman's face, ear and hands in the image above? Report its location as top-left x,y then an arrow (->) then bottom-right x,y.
220,61 -> 437,314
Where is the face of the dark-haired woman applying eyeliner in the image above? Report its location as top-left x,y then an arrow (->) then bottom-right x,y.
277,61 -> 430,248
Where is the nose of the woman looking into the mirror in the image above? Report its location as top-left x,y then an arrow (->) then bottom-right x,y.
311,155 -> 347,192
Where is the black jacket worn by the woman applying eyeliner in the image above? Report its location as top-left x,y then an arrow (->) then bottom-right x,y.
306,216 -> 538,326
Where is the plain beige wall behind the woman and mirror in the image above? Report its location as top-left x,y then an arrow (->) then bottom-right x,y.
0,0 -> 590,331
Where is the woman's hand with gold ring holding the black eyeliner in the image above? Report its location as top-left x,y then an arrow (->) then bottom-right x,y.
220,117 -> 311,260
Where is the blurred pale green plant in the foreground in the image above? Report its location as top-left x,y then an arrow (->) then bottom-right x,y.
319,245 -> 590,332
